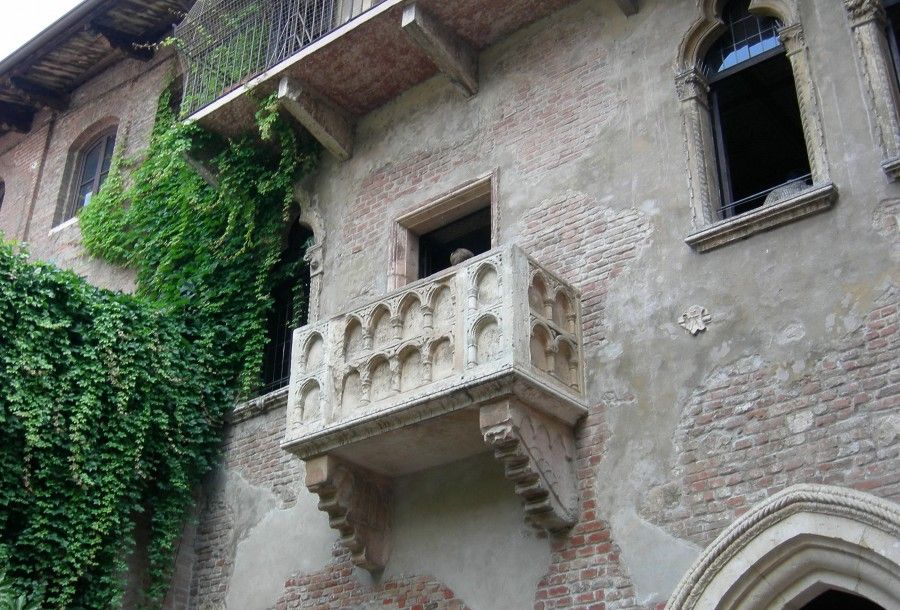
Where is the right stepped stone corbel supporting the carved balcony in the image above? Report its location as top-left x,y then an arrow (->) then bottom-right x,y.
479,400 -> 578,533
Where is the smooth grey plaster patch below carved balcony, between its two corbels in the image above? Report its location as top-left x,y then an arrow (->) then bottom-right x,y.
384,454 -> 550,610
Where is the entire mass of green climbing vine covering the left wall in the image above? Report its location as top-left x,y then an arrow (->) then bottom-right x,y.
0,88 -> 315,609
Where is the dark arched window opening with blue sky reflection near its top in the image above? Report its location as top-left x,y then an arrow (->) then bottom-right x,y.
703,0 -> 811,218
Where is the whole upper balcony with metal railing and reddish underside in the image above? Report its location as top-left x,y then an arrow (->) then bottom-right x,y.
176,0 -> 637,151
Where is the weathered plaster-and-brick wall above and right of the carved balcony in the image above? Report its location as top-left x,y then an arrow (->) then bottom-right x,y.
260,0 -> 900,608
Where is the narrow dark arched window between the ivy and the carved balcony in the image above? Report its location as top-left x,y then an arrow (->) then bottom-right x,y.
260,222 -> 313,394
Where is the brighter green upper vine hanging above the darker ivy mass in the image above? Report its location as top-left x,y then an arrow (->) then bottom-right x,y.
79,89 -> 316,392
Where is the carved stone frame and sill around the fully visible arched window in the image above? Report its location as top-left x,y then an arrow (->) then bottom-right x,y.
675,0 -> 837,252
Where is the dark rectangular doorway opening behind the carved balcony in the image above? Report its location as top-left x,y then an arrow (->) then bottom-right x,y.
419,208 -> 491,279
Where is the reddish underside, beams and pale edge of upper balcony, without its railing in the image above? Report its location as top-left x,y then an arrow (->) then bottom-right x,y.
188,0 -> 638,153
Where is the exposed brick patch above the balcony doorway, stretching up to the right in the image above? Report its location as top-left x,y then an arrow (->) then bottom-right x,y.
343,12 -> 620,256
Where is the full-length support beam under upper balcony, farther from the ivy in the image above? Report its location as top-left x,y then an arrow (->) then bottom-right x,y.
401,3 -> 478,97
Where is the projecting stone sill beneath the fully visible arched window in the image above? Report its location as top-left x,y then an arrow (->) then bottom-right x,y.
684,183 -> 838,252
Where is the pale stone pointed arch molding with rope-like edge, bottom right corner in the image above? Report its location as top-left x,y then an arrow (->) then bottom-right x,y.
666,485 -> 900,610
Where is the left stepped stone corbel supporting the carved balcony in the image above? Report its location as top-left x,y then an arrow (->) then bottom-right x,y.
306,455 -> 391,572
